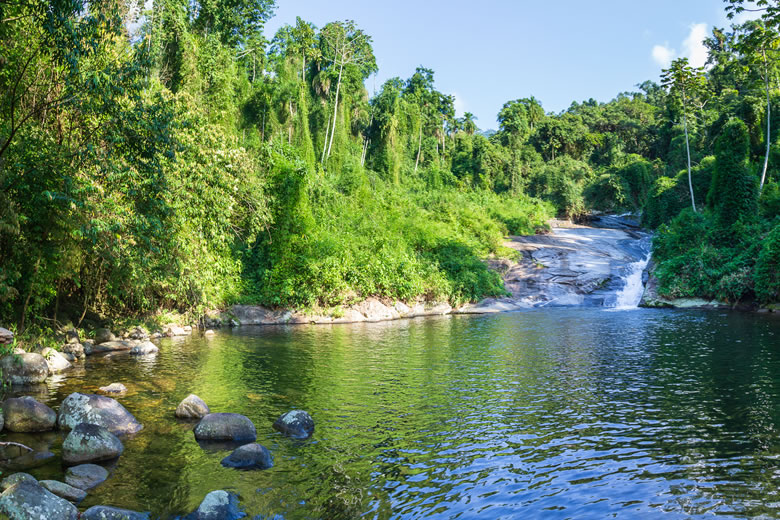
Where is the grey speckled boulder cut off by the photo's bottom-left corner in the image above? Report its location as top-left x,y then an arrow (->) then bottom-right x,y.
0,482 -> 79,520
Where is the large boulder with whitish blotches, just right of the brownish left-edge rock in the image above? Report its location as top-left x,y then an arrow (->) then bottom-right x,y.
57,392 -> 143,435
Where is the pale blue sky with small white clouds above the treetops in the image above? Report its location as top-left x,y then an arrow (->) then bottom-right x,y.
266,0 -> 756,129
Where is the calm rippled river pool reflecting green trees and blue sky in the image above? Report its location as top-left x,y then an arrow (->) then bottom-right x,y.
2,308 -> 780,519
